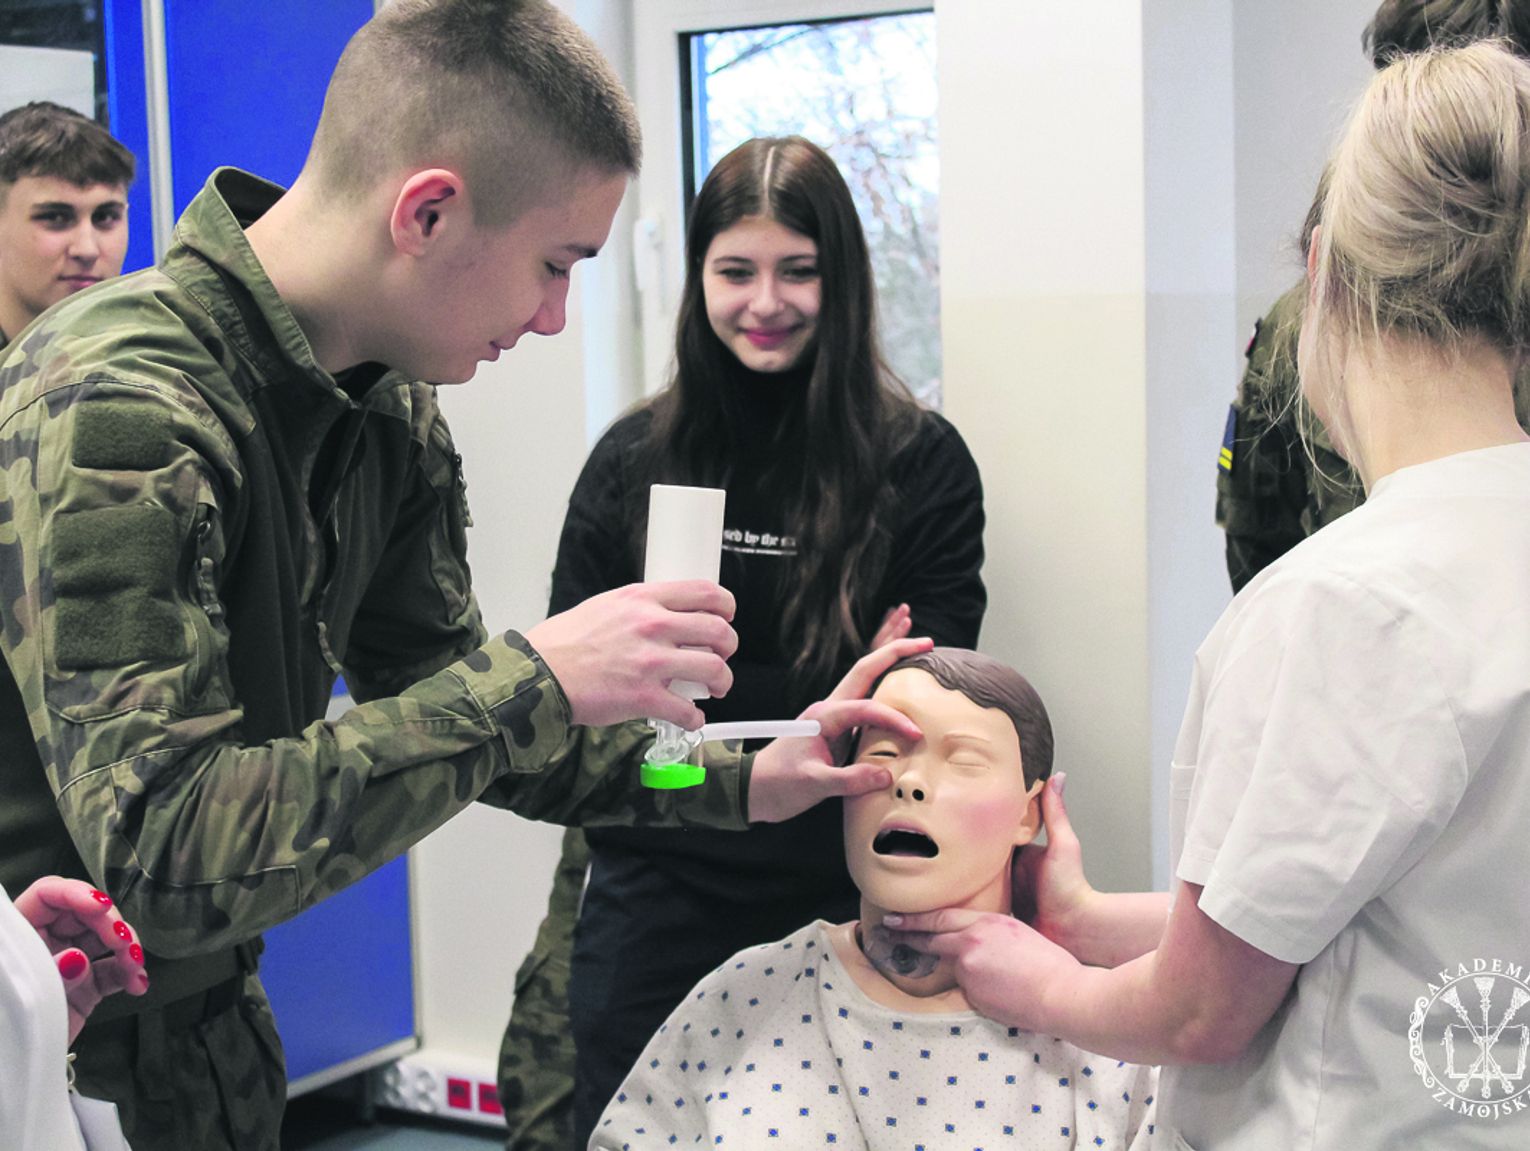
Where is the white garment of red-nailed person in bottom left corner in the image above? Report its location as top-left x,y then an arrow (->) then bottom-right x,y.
0,888 -> 84,1151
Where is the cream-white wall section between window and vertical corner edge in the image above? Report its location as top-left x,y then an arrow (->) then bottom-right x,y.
936,0 -> 1149,888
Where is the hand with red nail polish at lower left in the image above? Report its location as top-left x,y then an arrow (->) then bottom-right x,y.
15,875 -> 148,1042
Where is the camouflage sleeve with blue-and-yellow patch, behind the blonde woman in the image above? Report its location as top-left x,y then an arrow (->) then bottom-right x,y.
1216,288 -> 1307,592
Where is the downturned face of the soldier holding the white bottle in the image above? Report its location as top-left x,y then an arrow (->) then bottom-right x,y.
400,173 -> 627,384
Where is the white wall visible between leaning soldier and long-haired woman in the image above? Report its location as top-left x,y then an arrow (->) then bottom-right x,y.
413,0 -> 640,1067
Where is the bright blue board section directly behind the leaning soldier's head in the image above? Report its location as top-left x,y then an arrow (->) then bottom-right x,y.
164,0 -> 373,216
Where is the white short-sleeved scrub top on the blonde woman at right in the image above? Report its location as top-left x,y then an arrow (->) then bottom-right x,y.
1160,444 -> 1530,1151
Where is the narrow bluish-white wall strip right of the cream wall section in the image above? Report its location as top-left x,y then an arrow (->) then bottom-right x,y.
1143,0 -> 1238,888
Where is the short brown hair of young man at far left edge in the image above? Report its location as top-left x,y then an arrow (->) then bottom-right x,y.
0,99 -> 138,196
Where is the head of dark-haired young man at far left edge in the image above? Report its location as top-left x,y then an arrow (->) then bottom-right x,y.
0,101 -> 135,337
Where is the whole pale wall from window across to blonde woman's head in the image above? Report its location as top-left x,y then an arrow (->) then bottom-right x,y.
936,0 -> 1374,888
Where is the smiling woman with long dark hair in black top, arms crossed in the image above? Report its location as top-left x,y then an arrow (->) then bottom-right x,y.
502,136 -> 985,1146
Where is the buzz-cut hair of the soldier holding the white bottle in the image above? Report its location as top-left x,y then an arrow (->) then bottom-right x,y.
309,0 -> 643,227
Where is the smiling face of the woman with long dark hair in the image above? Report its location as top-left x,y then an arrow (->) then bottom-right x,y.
701,216 -> 822,372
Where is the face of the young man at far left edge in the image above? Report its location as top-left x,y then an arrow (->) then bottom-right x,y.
0,176 -> 127,337
